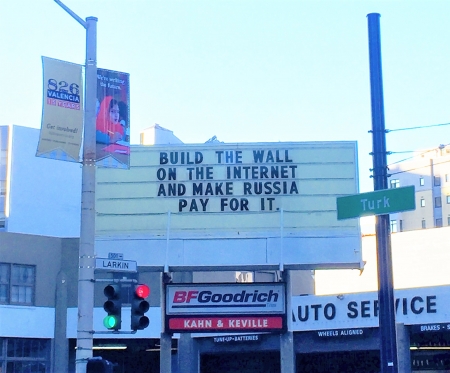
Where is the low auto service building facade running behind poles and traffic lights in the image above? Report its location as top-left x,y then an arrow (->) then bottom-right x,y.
0,227 -> 450,373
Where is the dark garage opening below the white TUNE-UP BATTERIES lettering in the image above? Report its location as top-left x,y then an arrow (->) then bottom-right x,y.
200,351 -> 280,373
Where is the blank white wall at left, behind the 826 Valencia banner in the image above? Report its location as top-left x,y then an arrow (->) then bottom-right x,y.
6,126 -> 81,237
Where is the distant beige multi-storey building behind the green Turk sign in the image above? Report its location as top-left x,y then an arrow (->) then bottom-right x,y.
389,145 -> 450,233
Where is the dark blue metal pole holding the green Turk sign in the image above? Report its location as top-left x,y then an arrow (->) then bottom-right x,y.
367,13 -> 398,373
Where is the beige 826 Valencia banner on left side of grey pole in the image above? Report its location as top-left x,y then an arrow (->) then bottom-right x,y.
36,57 -> 84,162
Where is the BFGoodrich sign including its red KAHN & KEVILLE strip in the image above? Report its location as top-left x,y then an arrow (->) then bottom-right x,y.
166,283 -> 286,333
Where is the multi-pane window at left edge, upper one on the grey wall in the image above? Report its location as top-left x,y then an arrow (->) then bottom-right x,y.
0,263 -> 36,304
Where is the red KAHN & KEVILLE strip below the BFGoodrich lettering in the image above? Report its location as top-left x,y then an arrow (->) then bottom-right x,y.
168,316 -> 283,332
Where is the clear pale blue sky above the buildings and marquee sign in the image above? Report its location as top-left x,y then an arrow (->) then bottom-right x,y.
0,0 -> 450,192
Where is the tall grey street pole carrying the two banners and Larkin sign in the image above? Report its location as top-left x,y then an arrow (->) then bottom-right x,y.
55,0 -> 98,373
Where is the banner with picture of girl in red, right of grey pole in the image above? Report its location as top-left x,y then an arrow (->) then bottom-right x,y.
95,69 -> 130,169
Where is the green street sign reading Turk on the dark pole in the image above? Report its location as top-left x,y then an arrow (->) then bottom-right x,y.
336,185 -> 416,220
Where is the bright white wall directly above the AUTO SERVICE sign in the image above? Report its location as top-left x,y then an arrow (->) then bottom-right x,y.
315,227 -> 450,295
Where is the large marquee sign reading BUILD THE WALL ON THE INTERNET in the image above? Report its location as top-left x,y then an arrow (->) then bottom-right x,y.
96,141 -> 362,270
